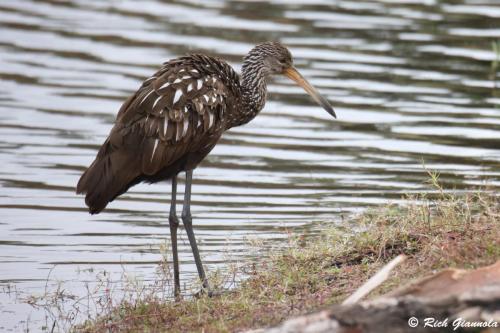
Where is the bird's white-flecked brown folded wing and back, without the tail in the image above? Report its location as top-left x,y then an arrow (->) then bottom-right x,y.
109,57 -> 235,175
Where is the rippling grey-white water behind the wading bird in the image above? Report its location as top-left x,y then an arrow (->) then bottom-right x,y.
0,0 -> 500,332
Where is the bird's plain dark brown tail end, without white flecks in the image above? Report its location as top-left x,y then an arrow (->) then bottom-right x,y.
76,141 -> 137,214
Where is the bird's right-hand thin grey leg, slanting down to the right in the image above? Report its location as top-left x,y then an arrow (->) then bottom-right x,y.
181,170 -> 210,293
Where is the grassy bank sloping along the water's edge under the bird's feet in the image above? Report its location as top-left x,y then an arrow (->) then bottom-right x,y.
72,173 -> 500,333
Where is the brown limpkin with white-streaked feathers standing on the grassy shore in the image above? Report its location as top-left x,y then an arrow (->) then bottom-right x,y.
76,42 -> 335,297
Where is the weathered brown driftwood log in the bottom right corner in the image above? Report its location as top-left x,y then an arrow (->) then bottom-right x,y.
248,261 -> 500,333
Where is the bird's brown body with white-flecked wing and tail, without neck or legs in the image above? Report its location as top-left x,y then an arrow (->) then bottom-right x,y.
77,55 -> 234,213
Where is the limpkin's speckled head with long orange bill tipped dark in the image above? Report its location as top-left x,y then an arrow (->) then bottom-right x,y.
245,42 -> 337,118
